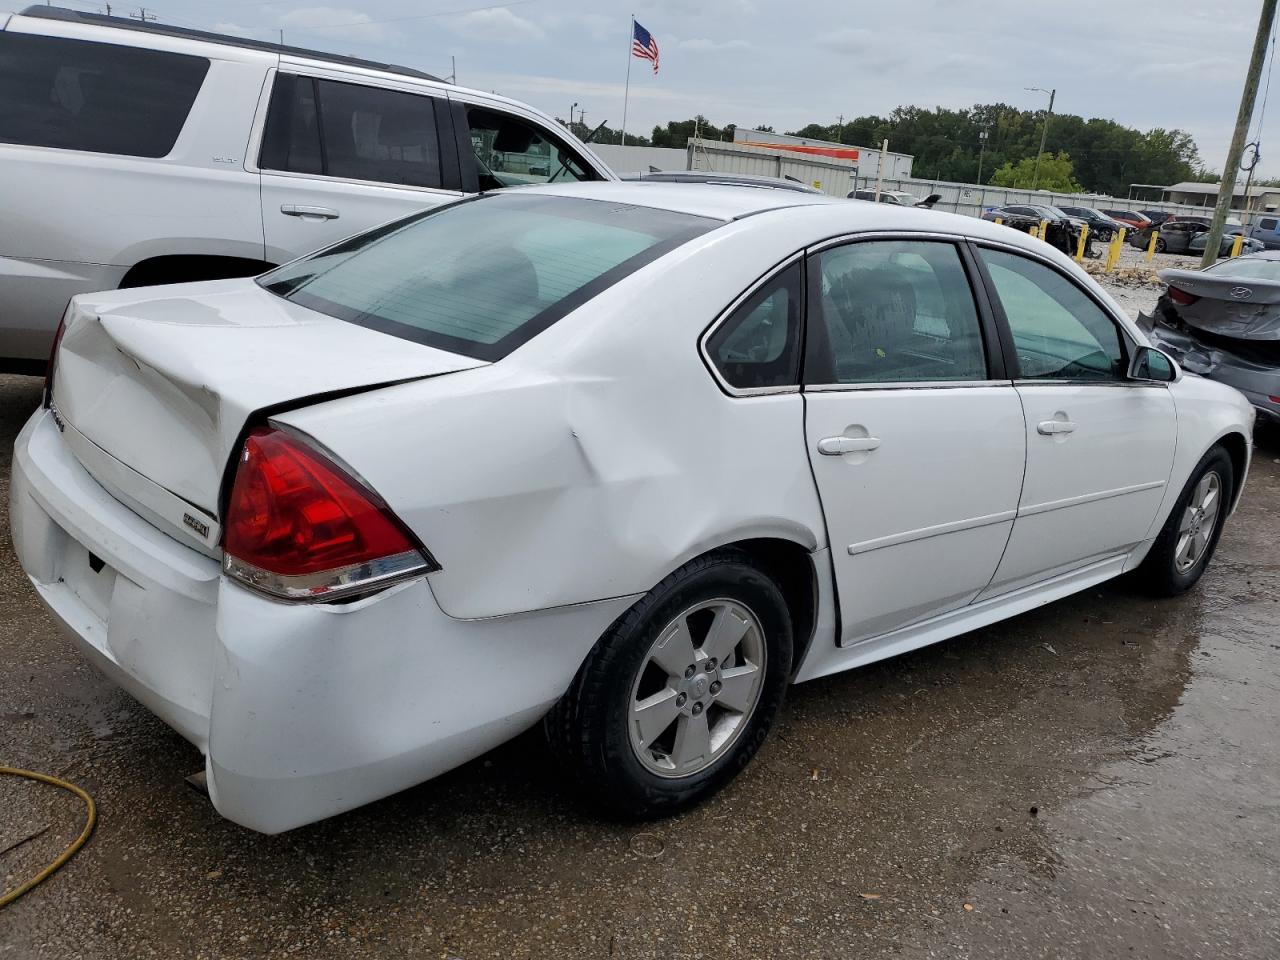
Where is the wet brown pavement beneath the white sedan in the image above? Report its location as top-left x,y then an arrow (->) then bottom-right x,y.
0,378 -> 1280,960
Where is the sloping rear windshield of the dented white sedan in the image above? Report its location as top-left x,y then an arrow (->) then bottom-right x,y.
259,189 -> 721,360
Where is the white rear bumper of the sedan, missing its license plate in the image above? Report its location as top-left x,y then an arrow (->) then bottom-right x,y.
10,411 -> 631,833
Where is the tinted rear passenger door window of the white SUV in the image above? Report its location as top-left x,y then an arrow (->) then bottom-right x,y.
259,73 -> 442,187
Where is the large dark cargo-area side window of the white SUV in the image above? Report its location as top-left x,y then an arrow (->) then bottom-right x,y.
0,31 -> 209,157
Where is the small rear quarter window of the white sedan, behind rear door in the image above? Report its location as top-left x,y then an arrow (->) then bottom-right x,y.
707,261 -> 800,389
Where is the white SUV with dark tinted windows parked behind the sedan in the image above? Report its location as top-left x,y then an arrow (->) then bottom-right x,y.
0,6 -> 616,372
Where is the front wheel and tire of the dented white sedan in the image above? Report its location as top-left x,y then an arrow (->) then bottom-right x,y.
1134,447 -> 1235,596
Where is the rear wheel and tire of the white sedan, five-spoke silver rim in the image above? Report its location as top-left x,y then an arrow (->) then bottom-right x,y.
543,549 -> 792,818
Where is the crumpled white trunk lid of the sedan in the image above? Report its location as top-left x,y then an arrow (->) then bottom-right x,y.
54,280 -> 483,549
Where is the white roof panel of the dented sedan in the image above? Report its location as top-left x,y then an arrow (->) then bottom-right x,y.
513,180 -> 849,220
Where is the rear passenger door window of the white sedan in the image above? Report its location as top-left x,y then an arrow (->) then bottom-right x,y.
806,241 -> 987,384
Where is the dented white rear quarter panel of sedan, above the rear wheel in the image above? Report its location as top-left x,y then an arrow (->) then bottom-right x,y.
279,214 -> 826,618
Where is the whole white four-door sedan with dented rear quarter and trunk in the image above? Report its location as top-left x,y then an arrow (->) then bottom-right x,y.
12,183 -> 1253,832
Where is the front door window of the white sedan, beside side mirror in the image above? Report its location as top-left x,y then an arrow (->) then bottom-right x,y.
979,250 -> 1126,380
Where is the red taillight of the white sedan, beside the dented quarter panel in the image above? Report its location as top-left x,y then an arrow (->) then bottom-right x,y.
223,426 -> 438,600
